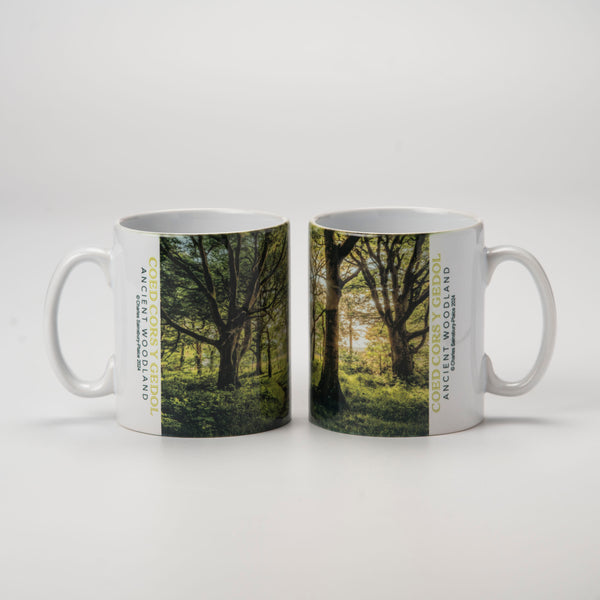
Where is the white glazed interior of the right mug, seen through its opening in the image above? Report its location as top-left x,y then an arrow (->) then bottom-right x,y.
313,208 -> 481,235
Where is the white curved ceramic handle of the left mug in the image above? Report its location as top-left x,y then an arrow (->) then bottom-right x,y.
44,248 -> 115,398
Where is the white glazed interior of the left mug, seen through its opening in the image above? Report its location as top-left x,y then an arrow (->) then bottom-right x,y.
119,208 -> 286,235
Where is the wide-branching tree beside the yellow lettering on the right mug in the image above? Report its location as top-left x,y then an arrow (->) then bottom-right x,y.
349,235 -> 429,380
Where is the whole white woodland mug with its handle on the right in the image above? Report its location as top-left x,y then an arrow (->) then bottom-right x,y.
310,208 -> 556,437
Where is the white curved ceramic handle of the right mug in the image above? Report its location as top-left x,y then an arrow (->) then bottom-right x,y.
485,246 -> 556,396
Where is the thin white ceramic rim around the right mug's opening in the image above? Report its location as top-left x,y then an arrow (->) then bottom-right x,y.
310,206 -> 483,235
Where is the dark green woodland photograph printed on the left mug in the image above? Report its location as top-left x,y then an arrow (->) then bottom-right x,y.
160,225 -> 289,437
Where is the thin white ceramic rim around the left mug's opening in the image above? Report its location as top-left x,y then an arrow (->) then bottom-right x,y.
116,208 -> 289,236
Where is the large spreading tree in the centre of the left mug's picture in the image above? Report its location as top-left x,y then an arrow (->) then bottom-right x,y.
160,227 -> 287,389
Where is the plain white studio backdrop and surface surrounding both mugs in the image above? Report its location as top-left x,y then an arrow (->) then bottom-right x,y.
0,0 -> 600,598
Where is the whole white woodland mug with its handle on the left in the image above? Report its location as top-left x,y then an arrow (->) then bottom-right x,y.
45,209 -> 290,437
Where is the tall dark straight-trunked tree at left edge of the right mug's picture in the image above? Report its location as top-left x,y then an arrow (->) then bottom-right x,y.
314,229 -> 360,413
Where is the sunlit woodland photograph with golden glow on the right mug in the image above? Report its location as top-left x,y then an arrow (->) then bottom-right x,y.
310,226 -> 429,436
